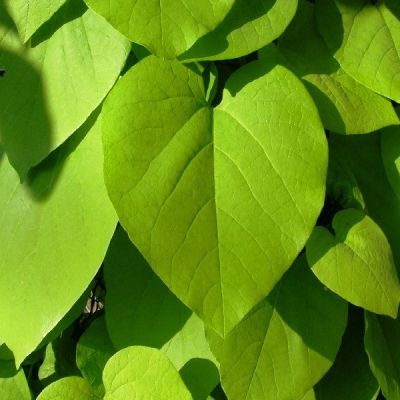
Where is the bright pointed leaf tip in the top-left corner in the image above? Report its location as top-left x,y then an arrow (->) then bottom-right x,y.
5,0 -> 66,43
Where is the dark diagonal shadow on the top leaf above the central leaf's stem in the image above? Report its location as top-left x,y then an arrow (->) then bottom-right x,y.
178,0 -> 276,60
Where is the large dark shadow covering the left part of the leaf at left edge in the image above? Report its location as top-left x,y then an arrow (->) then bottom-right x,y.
0,49 -> 52,178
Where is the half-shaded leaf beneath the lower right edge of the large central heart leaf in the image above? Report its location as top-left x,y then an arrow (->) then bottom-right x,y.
221,257 -> 347,400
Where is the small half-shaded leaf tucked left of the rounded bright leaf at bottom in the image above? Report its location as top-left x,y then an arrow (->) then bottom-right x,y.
76,317 -> 116,396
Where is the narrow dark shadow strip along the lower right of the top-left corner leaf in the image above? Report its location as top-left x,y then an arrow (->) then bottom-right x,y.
30,0 -> 87,47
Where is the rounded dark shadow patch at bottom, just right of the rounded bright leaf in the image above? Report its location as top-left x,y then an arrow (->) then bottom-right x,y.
179,358 -> 219,400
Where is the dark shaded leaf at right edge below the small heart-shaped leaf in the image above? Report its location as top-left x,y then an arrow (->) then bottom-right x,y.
364,312 -> 400,400
